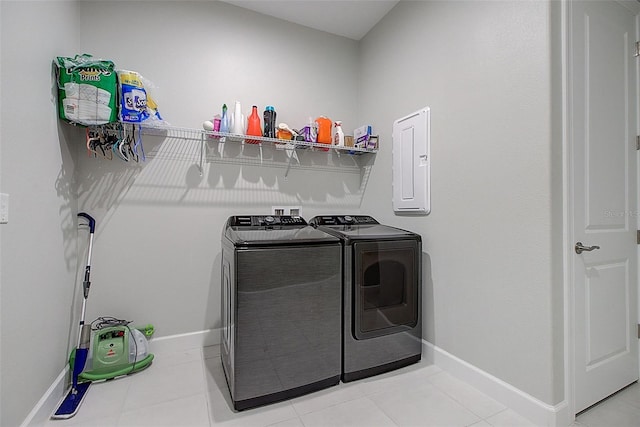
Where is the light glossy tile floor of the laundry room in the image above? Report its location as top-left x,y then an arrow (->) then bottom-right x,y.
43,346 -> 640,427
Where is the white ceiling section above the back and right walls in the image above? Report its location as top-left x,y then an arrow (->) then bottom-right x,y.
222,0 -> 398,40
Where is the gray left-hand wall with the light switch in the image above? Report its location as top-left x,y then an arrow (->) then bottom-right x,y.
0,1 -> 79,426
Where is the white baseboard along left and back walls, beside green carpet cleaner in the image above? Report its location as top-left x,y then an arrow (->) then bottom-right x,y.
20,329 -> 220,427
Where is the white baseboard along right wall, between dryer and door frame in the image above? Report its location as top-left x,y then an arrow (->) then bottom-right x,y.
422,340 -> 573,427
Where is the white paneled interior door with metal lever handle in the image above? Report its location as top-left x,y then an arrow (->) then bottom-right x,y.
568,1 -> 638,412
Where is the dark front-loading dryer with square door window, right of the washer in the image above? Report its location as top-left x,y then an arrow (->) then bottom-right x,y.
309,215 -> 422,382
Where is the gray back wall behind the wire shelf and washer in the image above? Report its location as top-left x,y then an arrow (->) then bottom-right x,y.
72,2 -> 362,337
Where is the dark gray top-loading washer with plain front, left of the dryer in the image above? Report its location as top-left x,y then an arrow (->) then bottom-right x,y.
220,216 -> 342,410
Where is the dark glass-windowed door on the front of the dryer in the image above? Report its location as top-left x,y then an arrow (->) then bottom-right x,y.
352,240 -> 421,339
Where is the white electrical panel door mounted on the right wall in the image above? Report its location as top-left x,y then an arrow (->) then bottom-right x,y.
392,107 -> 431,215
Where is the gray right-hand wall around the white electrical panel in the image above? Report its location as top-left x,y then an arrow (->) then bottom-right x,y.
358,1 -> 563,404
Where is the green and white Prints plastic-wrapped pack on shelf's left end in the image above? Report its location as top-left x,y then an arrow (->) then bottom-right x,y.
54,54 -> 118,126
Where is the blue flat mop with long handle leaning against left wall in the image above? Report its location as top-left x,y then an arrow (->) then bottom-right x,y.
51,212 -> 96,420
